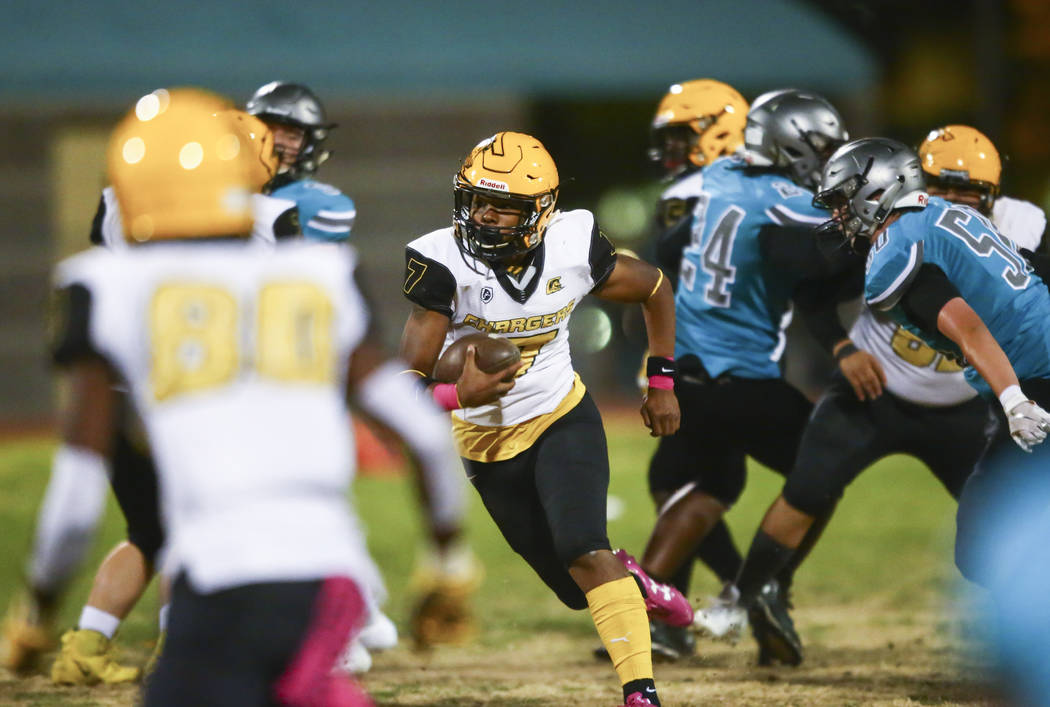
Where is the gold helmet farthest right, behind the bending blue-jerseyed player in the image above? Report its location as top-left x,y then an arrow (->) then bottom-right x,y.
919,125 -> 1003,213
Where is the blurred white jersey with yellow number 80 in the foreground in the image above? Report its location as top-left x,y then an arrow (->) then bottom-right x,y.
56,241 -> 375,591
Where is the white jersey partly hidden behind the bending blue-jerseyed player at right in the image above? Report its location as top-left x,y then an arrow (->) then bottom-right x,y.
849,196 -> 1046,407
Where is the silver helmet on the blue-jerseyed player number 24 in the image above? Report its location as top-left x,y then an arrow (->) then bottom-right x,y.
742,88 -> 849,189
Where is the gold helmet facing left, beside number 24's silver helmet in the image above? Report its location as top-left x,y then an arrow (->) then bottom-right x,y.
649,79 -> 748,176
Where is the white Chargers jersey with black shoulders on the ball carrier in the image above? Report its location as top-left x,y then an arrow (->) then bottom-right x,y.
403,209 -> 615,427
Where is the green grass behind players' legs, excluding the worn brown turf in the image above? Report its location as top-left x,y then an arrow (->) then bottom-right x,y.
0,415 -> 956,654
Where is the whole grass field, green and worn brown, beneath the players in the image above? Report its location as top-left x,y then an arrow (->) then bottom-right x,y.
0,407 -> 988,707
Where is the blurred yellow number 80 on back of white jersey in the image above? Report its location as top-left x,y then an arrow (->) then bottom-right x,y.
149,282 -> 335,401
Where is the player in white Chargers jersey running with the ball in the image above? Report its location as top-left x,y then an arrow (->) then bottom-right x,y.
401,132 -> 692,707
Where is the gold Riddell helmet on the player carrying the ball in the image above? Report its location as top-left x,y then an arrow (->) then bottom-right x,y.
453,132 -> 559,267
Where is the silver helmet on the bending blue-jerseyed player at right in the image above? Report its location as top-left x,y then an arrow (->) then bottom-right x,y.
813,138 -> 929,245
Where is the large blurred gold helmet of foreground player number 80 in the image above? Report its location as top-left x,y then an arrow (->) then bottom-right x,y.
107,88 -> 266,242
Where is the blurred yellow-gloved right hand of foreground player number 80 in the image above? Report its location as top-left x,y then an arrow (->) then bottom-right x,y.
410,547 -> 483,650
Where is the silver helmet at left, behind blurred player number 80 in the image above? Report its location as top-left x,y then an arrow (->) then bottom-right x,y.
245,81 -> 335,174
